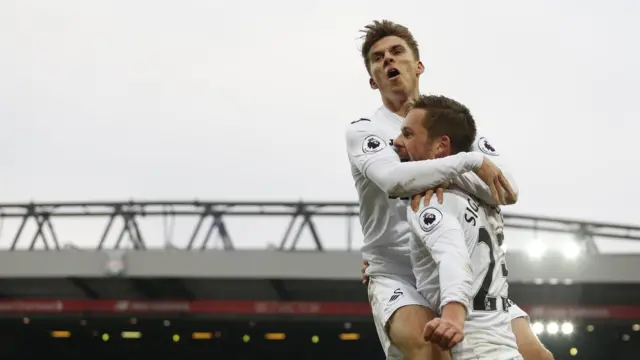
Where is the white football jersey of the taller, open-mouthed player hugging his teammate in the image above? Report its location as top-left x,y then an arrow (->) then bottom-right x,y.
346,106 -> 516,280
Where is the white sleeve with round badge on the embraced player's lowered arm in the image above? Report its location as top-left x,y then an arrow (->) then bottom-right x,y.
413,198 -> 473,313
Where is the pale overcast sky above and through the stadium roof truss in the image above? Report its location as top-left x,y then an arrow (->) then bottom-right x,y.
0,0 -> 640,253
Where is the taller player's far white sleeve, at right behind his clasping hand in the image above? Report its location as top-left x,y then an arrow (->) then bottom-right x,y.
452,136 -> 519,205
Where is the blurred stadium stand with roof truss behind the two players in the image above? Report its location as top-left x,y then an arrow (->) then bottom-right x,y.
0,202 -> 640,360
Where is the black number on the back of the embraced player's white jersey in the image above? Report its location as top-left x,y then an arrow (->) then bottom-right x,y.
473,227 -> 510,312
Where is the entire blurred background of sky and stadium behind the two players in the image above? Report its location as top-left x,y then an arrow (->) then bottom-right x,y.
0,0 -> 640,359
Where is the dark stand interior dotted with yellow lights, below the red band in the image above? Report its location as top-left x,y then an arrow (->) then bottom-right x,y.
0,316 -> 640,360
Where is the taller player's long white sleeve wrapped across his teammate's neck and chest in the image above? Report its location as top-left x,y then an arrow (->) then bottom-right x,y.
346,119 -> 483,197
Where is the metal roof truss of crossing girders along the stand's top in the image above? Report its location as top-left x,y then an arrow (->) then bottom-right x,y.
0,201 -> 640,251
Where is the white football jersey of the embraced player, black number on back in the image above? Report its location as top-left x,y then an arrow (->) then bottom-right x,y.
407,188 -> 520,360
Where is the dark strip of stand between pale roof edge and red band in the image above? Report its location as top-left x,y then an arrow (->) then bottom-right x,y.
0,277 -> 640,305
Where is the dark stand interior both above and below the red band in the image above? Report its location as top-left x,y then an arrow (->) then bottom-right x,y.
0,277 -> 640,360
